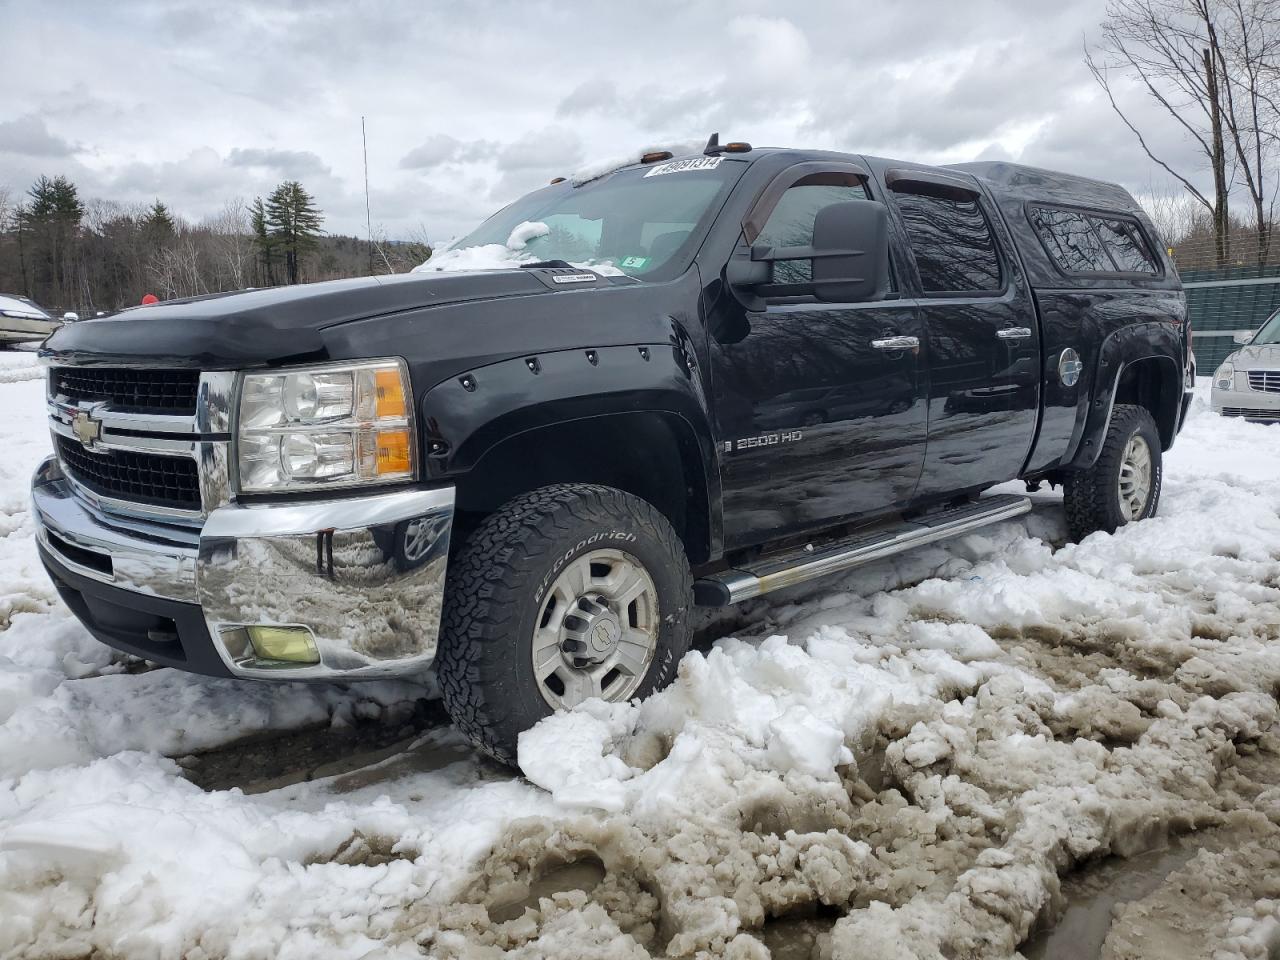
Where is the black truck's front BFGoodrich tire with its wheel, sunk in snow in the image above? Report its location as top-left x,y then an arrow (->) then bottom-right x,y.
436,484 -> 692,764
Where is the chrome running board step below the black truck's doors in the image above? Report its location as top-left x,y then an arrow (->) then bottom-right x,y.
694,494 -> 1032,607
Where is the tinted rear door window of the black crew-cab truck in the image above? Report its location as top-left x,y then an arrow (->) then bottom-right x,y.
895,189 -> 1004,296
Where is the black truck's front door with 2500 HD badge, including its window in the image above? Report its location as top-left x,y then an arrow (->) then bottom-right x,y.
710,163 -> 927,549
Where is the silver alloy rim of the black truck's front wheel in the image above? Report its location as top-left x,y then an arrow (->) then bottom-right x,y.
532,549 -> 660,709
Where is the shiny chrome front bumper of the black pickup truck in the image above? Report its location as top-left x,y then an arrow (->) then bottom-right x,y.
32,457 -> 453,680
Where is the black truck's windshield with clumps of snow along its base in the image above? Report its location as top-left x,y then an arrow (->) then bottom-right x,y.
430,156 -> 746,279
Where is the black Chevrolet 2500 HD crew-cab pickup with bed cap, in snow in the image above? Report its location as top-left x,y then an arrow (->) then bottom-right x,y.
40,138 -> 1194,762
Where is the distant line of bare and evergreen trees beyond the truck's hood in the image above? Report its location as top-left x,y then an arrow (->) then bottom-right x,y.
0,175 -> 431,315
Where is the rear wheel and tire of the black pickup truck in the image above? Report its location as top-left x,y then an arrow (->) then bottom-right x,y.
1062,404 -> 1164,540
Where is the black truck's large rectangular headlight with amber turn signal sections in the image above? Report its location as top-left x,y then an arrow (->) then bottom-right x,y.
236,360 -> 415,493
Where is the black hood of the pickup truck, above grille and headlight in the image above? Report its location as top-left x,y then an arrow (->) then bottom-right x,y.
41,269 -> 614,370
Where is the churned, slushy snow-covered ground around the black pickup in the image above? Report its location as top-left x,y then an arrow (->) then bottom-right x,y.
0,353 -> 1280,960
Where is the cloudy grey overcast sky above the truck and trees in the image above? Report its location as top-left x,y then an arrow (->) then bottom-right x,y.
0,0 -> 1208,239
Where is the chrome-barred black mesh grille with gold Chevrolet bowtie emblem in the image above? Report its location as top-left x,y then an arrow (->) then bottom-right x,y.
49,365 -> 236,525
